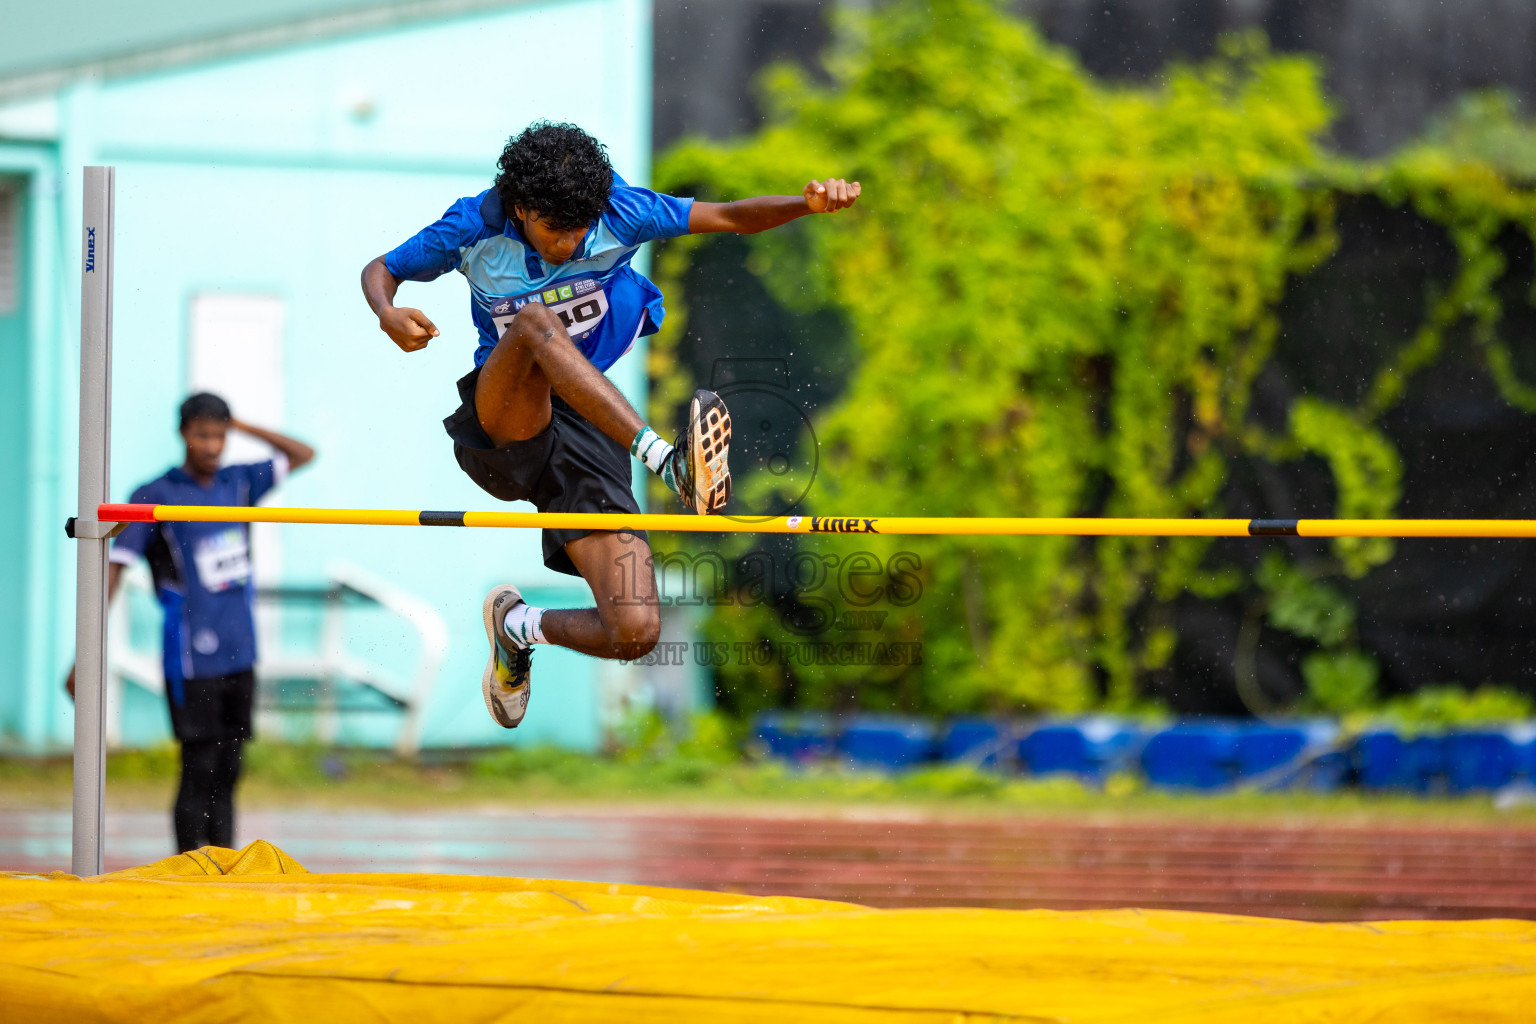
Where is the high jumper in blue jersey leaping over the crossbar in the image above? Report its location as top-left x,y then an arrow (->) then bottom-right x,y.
362,123 -> 859,729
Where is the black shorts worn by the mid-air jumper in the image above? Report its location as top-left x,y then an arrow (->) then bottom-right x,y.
442,367 -> 648,576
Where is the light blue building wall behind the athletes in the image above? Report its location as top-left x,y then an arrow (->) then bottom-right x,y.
0,0 -> 685,749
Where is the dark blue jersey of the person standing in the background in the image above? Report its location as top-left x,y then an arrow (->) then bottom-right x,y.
112,454 -> 287,705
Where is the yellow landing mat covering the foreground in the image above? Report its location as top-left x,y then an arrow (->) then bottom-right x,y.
0,843 -> 1536,1024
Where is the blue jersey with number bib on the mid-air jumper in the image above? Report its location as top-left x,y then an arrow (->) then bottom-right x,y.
384,173 -> 693,370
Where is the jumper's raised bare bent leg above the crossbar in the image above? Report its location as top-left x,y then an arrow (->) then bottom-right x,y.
475,302 -> 645,451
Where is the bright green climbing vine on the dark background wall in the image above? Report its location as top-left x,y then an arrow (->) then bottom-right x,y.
651,0 -> 1536,721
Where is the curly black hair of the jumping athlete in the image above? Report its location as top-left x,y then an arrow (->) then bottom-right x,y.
495,121 -> 613,229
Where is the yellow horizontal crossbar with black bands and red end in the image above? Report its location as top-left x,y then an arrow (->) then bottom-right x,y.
97,505 -> 1536,539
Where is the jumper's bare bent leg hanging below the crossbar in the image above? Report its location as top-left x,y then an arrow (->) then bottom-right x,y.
542,530 -> 662,660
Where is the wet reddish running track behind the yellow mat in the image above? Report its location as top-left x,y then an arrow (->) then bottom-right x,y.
0,809 -> 1536,921
